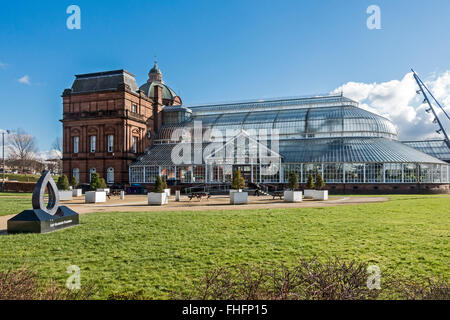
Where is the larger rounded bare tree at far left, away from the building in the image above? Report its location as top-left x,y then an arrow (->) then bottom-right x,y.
8,129 -> 37,172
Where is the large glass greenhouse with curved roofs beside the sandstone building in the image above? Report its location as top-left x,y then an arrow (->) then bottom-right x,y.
130,95 -> 450,184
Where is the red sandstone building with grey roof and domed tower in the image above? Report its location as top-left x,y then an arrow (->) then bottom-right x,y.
61,62 -> 181,184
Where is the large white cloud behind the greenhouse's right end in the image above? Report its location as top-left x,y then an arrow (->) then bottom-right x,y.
333,70 -> 450,140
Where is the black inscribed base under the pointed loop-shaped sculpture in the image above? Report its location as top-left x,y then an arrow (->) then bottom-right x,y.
8,206 -> 79,233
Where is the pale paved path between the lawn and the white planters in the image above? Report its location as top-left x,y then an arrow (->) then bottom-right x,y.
0,195 -> 389,233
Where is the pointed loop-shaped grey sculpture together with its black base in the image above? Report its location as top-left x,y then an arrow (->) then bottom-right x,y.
8,171 -> 79,233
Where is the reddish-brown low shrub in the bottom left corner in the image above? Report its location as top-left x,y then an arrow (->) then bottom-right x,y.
0,267 -> 94,300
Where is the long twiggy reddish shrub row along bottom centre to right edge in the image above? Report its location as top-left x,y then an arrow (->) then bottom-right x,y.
172,258 -> 450,300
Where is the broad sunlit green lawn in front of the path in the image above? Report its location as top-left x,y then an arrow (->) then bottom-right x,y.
0,192 -> 450,298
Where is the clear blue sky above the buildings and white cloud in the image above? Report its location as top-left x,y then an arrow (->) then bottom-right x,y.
0,0 -> 450,150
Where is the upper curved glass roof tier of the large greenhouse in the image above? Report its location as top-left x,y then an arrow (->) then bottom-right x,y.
160,106 -> 397,140
